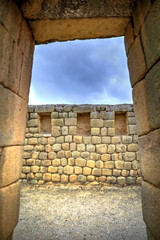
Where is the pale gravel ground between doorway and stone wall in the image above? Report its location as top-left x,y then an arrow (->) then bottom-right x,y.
13,185 -> 147,240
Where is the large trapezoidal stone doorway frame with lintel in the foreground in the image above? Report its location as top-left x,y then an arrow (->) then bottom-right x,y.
0,0 -> 160,240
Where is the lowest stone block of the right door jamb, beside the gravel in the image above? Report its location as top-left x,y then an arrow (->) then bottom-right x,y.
142,181 -> 160,239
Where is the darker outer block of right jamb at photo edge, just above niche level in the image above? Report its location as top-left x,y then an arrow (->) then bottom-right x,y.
145,61 -> 160,129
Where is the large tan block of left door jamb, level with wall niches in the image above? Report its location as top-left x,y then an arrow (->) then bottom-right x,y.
0,86 -> 27,146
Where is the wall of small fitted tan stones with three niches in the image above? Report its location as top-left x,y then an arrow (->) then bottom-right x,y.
21,105 -> 141,185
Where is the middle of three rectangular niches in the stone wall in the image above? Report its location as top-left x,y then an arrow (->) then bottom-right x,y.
77,113 -> 91,136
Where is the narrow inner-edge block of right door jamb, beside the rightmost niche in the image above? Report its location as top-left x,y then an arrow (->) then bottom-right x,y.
132,80 -> 151,135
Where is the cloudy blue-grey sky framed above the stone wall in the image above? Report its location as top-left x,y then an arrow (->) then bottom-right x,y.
29,37 -> 132,104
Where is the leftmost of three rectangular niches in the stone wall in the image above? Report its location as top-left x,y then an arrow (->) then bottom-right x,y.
39,113 -> 51,134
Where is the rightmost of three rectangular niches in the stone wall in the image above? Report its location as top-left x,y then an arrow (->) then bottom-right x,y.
115,112 -> 128,135
